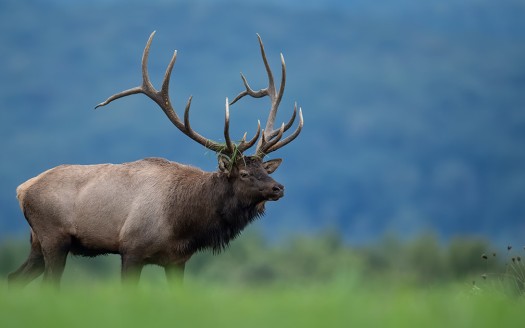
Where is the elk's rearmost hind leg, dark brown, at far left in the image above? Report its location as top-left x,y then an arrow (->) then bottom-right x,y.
7,231 -> 45,287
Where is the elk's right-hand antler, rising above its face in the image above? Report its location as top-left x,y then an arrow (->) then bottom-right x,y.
230,34 -> 303,157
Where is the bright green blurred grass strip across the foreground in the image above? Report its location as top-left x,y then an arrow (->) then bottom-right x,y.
0,280 -> 525,328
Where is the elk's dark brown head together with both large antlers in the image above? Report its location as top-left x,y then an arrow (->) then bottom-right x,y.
95,32 -> 303,202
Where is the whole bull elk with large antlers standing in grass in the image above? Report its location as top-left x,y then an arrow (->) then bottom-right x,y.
8,32 -> 303,285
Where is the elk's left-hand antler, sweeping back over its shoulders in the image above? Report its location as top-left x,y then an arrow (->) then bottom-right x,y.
95,31 -> 261,155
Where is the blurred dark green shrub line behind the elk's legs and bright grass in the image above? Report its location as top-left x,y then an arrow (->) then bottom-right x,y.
0,231 -> 505,286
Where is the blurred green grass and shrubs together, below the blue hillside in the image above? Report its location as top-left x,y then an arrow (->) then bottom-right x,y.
0,236 -> 525,328
